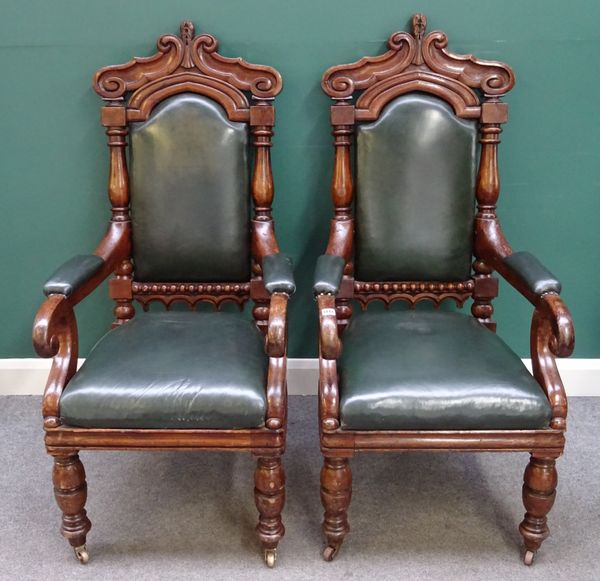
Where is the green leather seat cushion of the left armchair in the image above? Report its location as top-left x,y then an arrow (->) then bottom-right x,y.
60,312 -> 267,429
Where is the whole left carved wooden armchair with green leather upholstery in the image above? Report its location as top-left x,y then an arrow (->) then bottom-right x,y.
33,22 -> 295,566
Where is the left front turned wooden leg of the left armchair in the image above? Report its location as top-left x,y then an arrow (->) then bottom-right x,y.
52,454 -> 92,565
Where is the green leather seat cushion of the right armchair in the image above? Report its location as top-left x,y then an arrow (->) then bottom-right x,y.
339,310 -> 551,430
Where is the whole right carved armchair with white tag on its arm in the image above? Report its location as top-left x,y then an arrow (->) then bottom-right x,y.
314,14 -> 574,564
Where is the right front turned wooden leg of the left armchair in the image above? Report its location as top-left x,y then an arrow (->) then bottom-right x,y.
254,456 -> 285,567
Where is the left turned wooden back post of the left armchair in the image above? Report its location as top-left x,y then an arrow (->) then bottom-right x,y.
102,101 -> 135,327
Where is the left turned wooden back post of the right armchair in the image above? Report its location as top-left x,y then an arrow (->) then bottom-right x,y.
325,100 -> 354,333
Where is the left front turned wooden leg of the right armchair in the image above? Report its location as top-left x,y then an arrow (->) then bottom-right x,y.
321,458 -> 352,561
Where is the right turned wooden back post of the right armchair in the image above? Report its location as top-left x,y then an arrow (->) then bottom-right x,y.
471,97 -> 508,331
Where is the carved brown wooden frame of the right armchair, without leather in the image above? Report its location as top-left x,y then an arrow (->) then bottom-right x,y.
317,14 -> 574,564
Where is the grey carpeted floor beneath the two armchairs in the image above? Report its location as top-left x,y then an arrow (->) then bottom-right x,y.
0,396 -> 600,581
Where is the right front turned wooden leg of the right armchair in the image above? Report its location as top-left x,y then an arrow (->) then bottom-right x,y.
519,455 -> 558,565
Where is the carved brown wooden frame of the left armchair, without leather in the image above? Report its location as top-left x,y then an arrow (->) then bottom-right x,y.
33,21 -> 289,566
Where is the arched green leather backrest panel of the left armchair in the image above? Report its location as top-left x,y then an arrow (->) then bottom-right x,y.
131,93 -> 250,282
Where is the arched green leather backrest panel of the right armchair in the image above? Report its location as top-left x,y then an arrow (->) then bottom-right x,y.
355,93 -> 477,281
